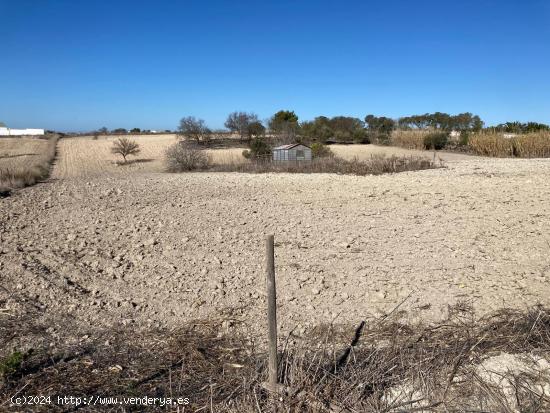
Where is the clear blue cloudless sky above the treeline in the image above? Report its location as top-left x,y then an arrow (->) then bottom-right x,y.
0,0 -> 550,131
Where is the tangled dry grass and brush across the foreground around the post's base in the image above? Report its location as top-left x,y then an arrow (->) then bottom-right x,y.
0,304 -> 550,413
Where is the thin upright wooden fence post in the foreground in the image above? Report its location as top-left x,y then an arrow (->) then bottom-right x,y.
266,235 -> 277,391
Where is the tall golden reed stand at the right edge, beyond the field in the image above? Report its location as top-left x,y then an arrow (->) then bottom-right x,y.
469,132 -> 550,158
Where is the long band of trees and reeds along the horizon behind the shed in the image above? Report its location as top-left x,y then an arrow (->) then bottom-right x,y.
85,109 -> 550,159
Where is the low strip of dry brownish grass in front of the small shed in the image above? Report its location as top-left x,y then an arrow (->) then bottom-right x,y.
210,155 -> 442,175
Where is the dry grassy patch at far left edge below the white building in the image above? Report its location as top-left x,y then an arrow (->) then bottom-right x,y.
0,135 -> 58,193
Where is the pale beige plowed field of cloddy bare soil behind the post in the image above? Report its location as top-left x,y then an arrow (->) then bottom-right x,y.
0,136 -> 550,338
